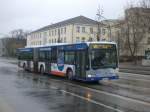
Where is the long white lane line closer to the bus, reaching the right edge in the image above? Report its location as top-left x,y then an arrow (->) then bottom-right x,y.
50,79 -> 150,106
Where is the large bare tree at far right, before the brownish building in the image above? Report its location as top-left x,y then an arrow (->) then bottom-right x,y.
121,5 -> 150,63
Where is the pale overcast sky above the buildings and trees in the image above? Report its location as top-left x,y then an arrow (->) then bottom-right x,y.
0,0 -> 138,35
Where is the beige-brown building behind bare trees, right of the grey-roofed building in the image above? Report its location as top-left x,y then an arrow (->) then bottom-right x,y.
101,7 -> 150,57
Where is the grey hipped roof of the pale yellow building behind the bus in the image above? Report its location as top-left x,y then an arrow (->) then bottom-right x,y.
31,16 -> 97,33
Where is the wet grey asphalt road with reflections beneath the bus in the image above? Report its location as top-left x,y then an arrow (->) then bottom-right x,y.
0,58 -> 150,112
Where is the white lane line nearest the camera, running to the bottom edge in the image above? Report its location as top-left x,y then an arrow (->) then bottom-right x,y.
50,86 -> 124,112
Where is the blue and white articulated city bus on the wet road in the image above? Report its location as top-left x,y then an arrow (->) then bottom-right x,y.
18,42 -> 118,81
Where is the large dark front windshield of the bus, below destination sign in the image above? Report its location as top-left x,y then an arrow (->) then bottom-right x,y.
91,49 -> 117,69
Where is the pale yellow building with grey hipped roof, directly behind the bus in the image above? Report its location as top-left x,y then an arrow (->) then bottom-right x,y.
27,16 -> 97,46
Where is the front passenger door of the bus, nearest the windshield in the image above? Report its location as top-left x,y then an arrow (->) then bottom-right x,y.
75,51 -> 86,78
